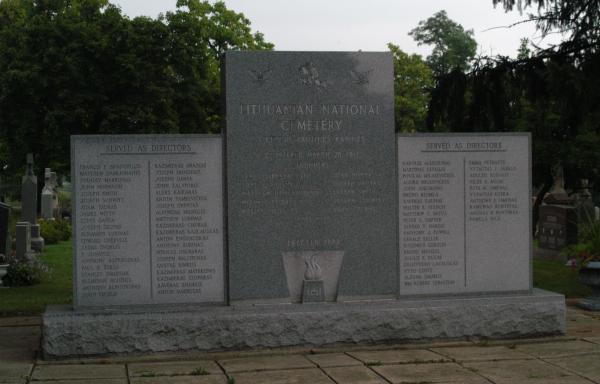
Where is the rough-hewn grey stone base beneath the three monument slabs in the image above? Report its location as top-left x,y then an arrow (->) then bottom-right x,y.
42,289 -> 566,358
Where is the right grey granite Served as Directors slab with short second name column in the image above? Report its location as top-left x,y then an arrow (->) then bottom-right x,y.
398,134 -> 532,296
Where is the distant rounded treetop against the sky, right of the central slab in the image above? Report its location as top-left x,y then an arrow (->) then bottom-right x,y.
409,10 -> 477,76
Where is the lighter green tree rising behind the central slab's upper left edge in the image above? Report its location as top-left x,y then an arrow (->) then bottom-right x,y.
162,0 -> 273,133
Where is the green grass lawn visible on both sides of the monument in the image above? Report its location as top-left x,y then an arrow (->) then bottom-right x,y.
0,241 -> 591,317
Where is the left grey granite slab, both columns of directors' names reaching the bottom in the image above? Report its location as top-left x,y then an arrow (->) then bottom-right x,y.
71,135 -> 225,307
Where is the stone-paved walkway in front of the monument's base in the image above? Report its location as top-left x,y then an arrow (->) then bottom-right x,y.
0,306 -> 600,384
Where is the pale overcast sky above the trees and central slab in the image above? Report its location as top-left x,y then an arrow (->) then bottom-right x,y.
111,0 -> 561,57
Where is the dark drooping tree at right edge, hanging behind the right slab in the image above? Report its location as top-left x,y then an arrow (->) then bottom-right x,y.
427,0 -> 600,228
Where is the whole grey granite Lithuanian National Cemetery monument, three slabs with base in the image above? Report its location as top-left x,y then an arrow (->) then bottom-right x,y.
43,52 -> 565,357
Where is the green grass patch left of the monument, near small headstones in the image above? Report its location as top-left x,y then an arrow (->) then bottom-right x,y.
0,241 -> 73,317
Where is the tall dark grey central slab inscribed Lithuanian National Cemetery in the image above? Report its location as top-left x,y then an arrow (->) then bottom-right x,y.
224,52 -> 397,302
